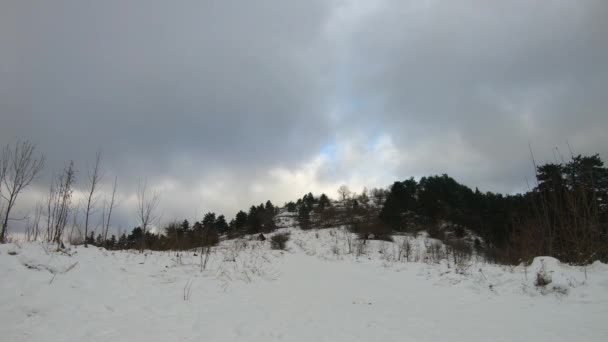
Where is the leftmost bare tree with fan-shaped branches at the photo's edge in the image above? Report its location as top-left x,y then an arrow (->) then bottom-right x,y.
0,141 -> 44,243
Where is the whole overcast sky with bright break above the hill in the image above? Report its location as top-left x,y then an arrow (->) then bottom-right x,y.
0,0 -> 608,229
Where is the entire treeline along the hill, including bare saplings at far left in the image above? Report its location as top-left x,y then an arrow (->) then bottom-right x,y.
0,141 -> 608,264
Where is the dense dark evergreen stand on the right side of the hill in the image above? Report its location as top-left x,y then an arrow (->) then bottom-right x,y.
379,155 -> 608,264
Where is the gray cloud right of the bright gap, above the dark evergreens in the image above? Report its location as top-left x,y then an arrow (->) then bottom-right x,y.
350,0 -> 608,191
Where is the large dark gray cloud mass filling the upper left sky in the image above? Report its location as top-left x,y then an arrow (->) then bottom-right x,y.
2,1 -> 327,179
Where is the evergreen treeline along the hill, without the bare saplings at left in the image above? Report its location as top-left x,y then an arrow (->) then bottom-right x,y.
92,155 -> 608,264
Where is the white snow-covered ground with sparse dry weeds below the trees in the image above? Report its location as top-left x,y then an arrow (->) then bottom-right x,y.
0,229 -> 608,342
